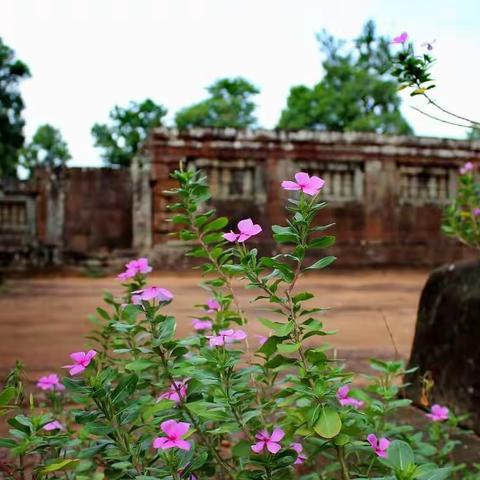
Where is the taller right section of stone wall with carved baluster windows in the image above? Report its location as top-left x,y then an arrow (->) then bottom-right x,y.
137,129 -> 480,266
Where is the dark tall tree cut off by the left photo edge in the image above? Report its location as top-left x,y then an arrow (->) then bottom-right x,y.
0,38 -> 30,177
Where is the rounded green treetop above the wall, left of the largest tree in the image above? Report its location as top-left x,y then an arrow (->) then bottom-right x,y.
175,77 -> 259,130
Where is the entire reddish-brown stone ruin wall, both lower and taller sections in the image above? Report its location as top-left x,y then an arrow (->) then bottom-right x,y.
0,129 -> 480,270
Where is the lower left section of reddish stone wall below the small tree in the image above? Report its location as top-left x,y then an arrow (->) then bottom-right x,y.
0,168 -> 132,270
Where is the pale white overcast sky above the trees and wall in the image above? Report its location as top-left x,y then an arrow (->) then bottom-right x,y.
0,0 -> 480,166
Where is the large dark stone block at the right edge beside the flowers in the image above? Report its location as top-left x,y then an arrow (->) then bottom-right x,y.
407,261 -> 480,432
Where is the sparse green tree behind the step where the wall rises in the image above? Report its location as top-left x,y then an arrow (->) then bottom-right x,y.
92,98 -> 167,166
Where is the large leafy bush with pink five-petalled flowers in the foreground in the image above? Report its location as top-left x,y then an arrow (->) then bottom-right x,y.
0,170 -> 472,480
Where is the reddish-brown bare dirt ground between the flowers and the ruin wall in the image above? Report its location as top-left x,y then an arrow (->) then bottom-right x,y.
0,270 -> 427,378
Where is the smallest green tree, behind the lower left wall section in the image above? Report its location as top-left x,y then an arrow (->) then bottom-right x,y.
20,124 -> 72,173
